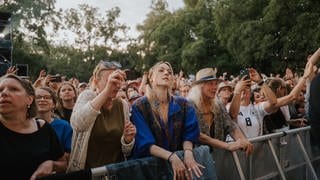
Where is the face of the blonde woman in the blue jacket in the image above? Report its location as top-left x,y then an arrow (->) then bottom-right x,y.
151,63 -> 173,87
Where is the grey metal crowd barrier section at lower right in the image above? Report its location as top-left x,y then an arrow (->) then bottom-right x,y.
213,127 -> 320,180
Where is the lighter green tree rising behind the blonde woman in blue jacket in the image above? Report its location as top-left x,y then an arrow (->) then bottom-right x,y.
136,0 -> 232,73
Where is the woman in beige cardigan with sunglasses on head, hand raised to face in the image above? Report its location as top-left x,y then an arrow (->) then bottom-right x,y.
68,61 -> 136,171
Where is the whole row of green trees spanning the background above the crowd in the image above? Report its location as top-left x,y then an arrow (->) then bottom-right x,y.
0,0 -> 320,80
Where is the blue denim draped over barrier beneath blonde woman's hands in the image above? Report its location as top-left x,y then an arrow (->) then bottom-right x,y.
102,146 -> 217,180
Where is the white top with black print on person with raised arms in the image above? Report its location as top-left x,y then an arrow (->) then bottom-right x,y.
237,102 -> 268,138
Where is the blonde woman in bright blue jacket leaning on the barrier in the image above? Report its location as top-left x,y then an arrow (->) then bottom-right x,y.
131,62 -> 204,179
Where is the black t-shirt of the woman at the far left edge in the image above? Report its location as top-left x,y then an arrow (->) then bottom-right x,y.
0,122 -> 64,180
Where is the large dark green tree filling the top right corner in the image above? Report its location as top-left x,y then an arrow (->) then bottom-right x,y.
214,0 -> 320,73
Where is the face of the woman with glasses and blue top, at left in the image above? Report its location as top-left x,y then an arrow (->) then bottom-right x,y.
35,89 -> 55,113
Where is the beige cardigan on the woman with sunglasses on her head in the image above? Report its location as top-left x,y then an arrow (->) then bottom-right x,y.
67,90 -> 134,172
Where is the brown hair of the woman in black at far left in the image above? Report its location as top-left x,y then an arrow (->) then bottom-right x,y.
0,74 -> 38,118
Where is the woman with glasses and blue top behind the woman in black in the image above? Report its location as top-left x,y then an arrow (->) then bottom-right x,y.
35,87 -> 72,159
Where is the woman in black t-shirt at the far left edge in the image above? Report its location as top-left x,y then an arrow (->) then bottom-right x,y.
0,74 -> 67,179
